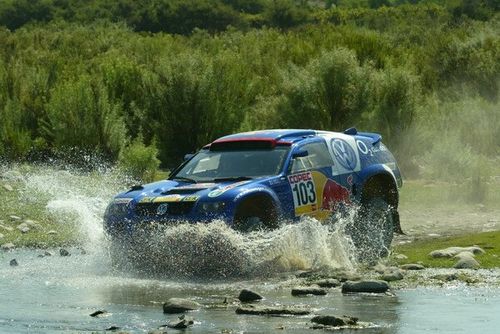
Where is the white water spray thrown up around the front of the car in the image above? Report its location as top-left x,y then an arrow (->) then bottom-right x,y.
4,166 -> 355,279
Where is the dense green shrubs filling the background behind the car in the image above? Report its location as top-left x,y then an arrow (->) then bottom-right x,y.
0,0 -> 500,190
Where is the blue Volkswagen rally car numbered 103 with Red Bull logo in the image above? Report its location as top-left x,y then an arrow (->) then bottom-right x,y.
104,128 -> 402,255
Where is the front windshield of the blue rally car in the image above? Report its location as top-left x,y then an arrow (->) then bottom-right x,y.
171,147 -> 290,182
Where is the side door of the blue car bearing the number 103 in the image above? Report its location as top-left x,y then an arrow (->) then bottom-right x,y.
288,140 -> 350,220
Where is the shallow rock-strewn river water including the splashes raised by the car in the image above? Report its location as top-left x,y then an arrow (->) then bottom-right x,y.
0,169 -> 500,333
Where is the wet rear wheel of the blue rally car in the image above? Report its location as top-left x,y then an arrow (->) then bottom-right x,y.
346,197 -> 395,264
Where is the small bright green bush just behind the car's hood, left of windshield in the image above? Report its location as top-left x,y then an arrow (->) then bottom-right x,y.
118,136 -> 160,182
